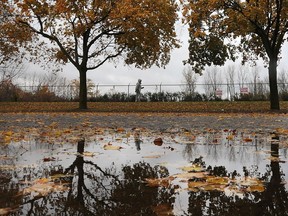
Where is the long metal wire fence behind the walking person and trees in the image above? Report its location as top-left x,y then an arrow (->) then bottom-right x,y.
12,83 -> 288,101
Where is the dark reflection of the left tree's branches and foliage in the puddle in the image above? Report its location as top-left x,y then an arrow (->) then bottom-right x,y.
1,143 -> 174,216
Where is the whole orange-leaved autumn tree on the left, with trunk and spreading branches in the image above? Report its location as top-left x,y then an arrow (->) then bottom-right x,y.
2,0 -> 179,109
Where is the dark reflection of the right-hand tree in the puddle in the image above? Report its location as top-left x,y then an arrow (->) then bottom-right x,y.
188,140 -> 288,216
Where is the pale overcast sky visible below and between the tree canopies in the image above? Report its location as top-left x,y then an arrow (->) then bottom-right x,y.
28,23 -> 288,85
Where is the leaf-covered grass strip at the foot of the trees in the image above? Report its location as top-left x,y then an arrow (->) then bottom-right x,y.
0,101 -> 288,113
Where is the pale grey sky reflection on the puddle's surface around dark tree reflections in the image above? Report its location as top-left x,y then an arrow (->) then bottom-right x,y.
0,130 -> 288,214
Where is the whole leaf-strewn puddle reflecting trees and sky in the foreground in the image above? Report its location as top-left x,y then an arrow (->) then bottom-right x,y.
0,128 -> 288,216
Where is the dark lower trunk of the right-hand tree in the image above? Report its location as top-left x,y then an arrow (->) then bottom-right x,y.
269,58 -> 280,110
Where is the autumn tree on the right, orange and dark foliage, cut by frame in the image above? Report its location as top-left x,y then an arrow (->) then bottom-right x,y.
182,0 -> 288,110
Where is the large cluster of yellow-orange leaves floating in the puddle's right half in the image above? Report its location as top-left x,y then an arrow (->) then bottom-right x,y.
145,158 -> 265,196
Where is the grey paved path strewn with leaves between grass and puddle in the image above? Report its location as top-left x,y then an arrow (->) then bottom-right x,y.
0,112 -> 288,132
